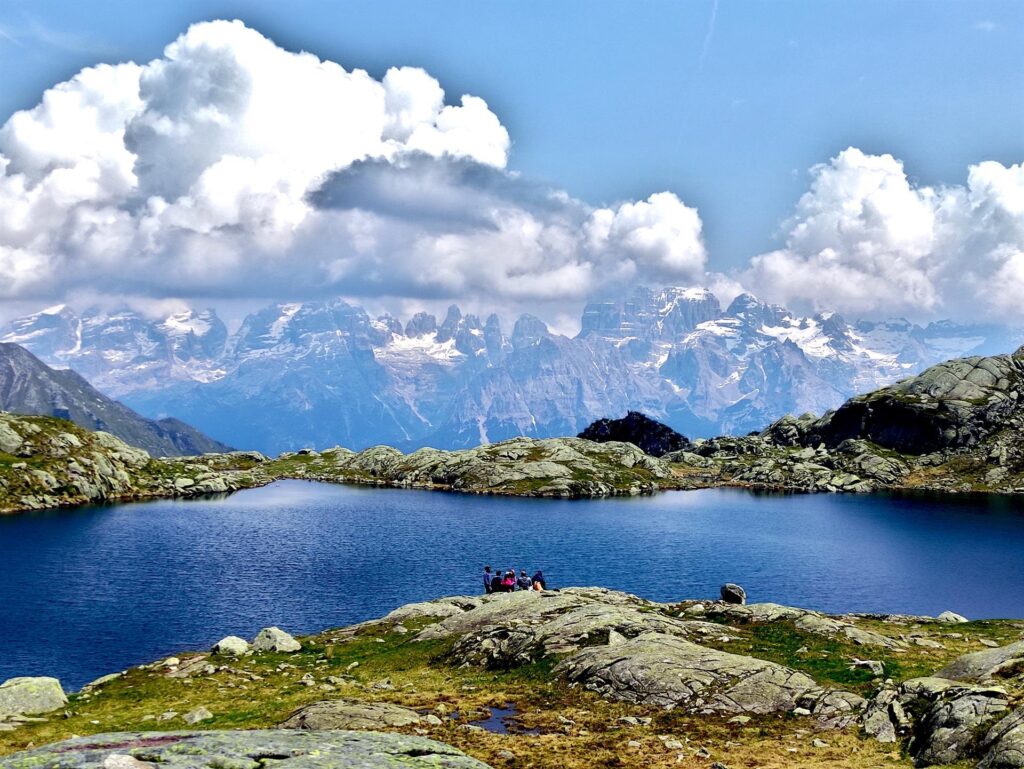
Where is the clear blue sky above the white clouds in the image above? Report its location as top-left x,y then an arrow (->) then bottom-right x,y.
0,0 -> 1024,266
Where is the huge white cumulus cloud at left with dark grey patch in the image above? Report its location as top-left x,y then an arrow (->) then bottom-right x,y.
0,22 -> 706,309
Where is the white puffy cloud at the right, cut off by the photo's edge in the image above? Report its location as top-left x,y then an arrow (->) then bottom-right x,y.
740,147 -> 1024,319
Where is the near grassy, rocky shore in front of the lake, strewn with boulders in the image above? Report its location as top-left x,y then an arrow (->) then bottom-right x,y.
0,588 -> 1024,769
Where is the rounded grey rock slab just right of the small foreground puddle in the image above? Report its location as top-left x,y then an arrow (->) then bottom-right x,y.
555,633 -> 820,714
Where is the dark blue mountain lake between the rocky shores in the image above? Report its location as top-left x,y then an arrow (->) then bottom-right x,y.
0,481 -> 1024,688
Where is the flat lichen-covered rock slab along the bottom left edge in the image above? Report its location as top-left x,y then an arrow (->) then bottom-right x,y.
0,729 -> 488,769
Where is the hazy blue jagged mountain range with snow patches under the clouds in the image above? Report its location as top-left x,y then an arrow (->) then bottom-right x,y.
0,288 -> 1024,453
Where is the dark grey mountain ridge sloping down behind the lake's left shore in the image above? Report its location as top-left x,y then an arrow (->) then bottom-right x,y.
0,343 -> 230,457
